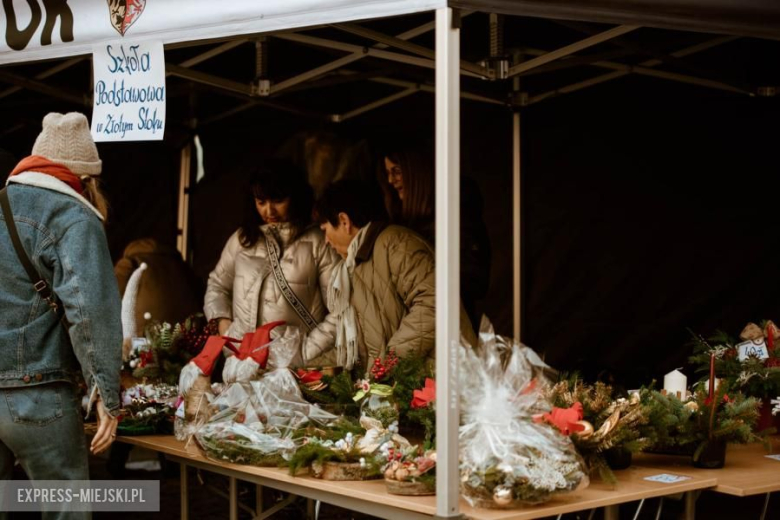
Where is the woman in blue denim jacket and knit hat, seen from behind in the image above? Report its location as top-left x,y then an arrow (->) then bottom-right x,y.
0,113 -> 122,494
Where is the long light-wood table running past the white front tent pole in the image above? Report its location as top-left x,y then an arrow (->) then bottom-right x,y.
117,435 -> 720,520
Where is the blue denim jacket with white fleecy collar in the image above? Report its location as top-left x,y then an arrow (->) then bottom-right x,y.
0,172 -> 122,414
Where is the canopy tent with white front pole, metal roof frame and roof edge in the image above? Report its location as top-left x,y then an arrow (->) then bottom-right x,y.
0,0 -> 780,517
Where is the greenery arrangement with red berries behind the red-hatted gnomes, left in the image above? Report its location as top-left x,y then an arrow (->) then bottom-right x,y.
124,314 -> 217,384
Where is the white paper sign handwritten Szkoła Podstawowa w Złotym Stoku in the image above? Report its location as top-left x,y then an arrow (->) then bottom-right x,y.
92,41 -> 166,141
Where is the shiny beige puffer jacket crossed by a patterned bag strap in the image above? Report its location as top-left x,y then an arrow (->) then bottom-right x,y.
203,224 -> 338,351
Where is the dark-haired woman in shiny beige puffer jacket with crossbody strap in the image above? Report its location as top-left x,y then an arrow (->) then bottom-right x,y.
204,161 -> 338,360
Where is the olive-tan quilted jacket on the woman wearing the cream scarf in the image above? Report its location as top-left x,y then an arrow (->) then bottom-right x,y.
303,222 -> 474,368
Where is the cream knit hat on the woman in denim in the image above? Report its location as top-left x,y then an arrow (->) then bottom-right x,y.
32,112 -> 103,176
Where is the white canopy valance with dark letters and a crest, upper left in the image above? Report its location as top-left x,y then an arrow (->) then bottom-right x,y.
0,0 -> 447,65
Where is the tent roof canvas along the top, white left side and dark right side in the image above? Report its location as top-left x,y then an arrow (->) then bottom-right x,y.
0,0 -> 780,65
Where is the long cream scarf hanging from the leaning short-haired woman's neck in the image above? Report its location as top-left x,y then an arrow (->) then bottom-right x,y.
328,223 -> 371,370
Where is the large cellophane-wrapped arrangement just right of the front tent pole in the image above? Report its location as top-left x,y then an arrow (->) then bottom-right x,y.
459,318 -> 588,508
